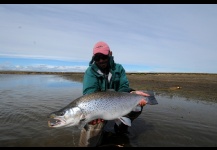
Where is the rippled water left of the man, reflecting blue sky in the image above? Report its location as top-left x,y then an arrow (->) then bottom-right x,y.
0,75 -> 82,146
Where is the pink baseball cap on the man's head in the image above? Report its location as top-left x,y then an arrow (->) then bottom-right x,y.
93,41 -> 110,55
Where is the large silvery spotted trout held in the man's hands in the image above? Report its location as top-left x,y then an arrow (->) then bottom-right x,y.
48,91 -> 157,129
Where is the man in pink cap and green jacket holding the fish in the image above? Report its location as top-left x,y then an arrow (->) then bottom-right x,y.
79,41 -> 149,146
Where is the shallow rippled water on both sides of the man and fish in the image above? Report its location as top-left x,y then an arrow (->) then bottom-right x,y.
0,74 -> 217,147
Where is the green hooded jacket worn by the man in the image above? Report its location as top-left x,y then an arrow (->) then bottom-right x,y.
83,56 -> 133,95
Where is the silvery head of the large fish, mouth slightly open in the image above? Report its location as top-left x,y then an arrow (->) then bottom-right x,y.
48,107 -> 84,128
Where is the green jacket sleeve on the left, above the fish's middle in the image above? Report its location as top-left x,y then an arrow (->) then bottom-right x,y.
83,68 -> 100,95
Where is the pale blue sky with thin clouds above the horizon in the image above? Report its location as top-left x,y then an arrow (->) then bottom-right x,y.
0,4 -> 217,73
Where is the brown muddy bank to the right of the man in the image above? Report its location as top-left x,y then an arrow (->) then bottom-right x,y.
128,73 -> 217,102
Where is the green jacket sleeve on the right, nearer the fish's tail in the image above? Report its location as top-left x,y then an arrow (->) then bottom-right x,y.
118,65 -> 134,92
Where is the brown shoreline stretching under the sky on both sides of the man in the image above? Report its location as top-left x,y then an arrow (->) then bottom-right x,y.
0,71 -> 217,102
